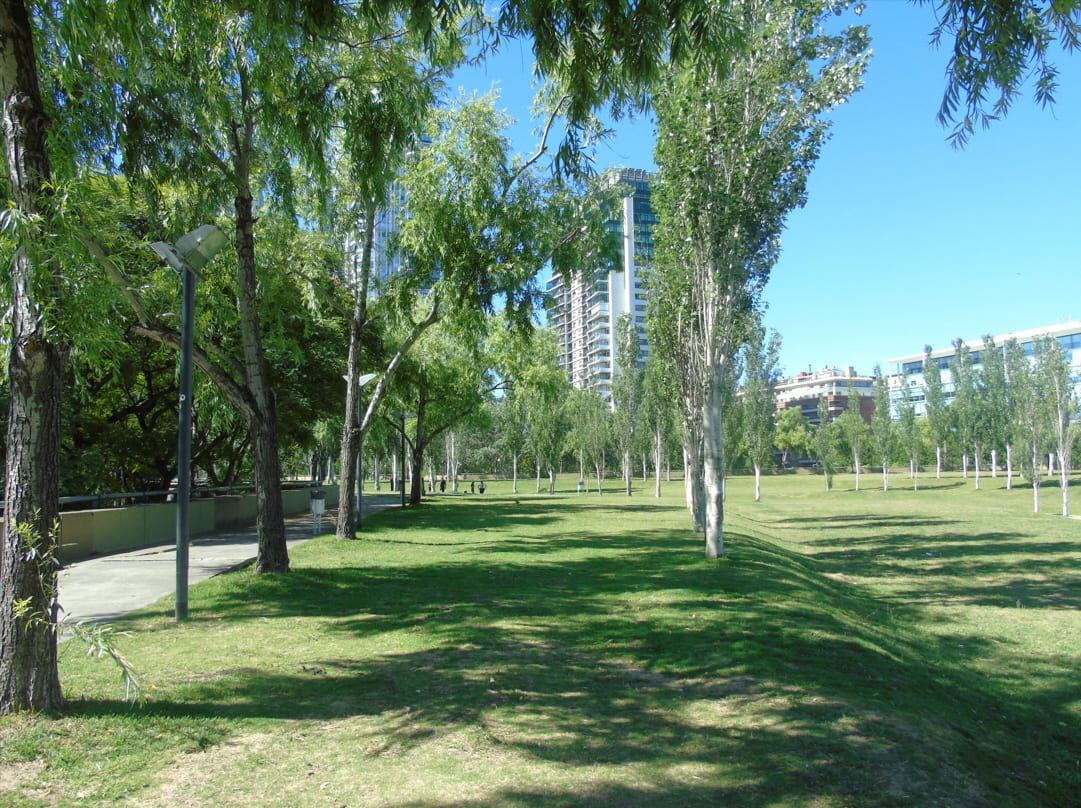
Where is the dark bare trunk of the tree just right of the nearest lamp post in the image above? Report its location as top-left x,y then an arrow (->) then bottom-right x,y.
235,193 -> 289,573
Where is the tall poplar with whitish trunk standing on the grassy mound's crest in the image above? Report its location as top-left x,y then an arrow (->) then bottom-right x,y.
654,0 -> 869,558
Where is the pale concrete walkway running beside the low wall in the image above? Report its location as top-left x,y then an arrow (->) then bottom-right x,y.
58,495 -> 401,622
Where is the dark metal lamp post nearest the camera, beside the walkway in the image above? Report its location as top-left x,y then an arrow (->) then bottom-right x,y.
150,225 -> 226,621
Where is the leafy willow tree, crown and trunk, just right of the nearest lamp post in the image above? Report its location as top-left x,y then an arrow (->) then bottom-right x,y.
54,0 -> 376,572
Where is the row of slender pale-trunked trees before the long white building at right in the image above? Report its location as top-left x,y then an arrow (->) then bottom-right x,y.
799,335 -> 1081,516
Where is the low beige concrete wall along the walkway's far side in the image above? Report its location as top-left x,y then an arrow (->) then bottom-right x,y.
59,486 -> 338,561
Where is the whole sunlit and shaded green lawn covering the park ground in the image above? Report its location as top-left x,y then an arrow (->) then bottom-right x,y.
0,475 -> 1081,808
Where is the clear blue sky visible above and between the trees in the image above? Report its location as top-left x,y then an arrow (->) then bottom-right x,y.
456,0 -> 1081,374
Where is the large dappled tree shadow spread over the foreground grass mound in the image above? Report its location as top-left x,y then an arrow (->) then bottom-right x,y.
77,519 -> 1081,808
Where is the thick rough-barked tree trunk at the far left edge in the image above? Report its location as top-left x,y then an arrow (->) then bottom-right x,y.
0,0 -> 64,714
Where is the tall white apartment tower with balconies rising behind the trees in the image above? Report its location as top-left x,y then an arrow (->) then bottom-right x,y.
547,169 -> 656,402
